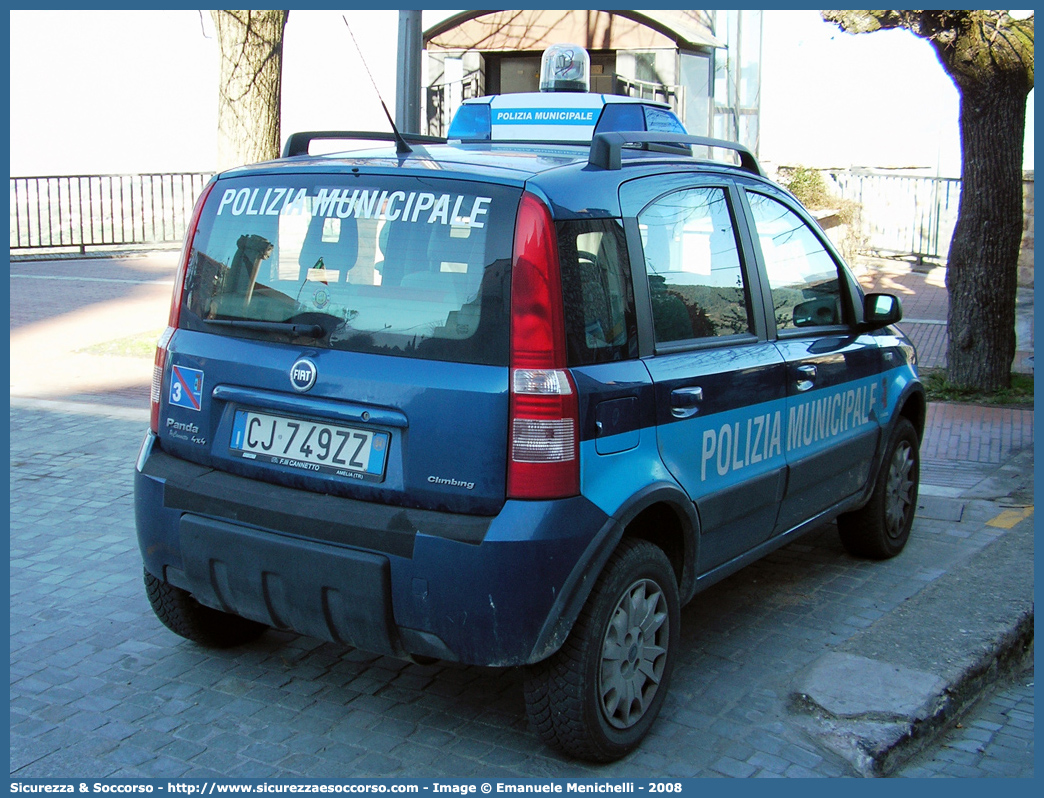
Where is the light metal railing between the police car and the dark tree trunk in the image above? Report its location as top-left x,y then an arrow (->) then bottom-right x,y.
827,170 -> 960,261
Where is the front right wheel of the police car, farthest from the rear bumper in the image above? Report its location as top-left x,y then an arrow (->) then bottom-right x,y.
837,418 -> 921,560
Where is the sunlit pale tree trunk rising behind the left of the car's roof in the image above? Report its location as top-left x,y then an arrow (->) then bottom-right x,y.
211,10 -> 289,170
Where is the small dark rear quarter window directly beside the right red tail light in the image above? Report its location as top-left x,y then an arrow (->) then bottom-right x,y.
557,219 -> 638,366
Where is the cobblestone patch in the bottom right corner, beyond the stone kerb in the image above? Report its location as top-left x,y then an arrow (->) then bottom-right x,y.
896,667 -> 1034,778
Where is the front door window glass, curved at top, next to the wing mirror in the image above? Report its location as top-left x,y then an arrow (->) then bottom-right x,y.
746,191 -> 845,330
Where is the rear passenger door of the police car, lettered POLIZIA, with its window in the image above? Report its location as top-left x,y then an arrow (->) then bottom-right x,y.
621,173 -> 786,572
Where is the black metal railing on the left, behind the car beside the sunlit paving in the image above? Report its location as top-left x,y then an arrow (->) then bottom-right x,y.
10,172 -> 213,252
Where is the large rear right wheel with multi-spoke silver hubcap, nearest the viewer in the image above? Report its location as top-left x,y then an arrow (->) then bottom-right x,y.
525,539 -> 681,761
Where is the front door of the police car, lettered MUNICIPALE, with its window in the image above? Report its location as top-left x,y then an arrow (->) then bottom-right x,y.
743,186 -> 882,533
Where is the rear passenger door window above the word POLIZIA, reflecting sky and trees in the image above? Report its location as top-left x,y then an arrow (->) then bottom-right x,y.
638,188 -> 754,344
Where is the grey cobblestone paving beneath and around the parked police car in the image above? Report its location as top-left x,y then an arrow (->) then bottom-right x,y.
10,405 -> 1027,778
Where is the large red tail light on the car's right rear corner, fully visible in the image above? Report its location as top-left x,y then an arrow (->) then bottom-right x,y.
507,193 -> 580,499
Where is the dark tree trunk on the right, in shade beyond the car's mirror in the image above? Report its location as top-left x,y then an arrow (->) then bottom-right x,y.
946,80 -> 1026,391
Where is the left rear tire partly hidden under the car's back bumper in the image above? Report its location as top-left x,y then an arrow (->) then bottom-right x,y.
145,570 -> 268,649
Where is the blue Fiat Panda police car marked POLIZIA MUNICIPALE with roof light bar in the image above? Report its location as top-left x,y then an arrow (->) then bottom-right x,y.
135,43 -> 925,760
